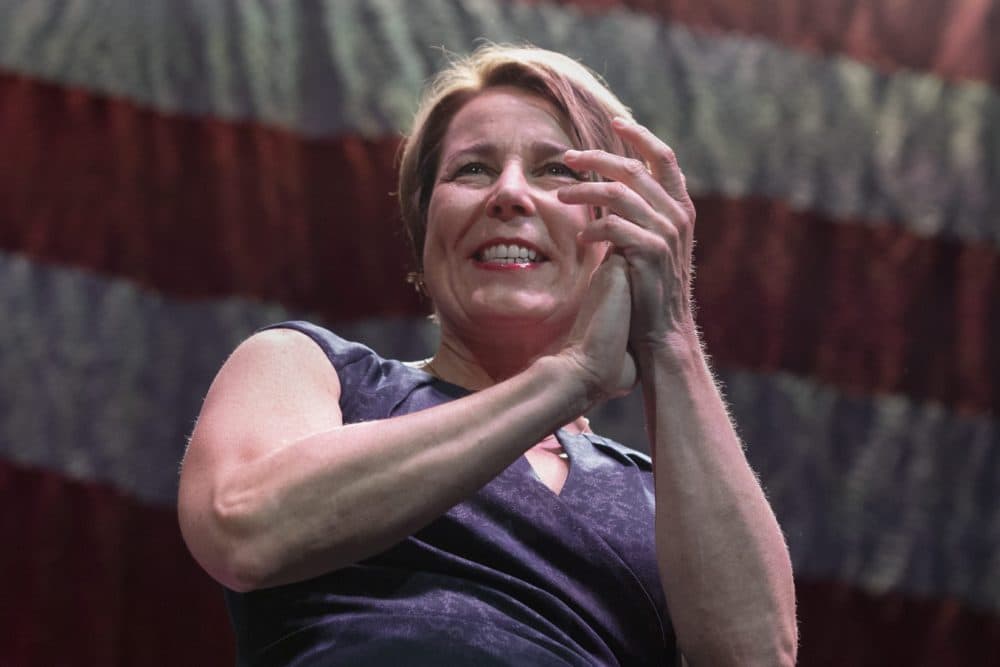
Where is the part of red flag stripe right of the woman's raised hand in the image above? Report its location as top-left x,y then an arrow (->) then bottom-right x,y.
695,198 -> 1000,412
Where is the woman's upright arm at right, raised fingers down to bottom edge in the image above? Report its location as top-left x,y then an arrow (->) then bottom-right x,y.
560,122 -> 797,667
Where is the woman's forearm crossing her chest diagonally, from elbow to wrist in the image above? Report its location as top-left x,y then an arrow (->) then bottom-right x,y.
208,357 -> 589,588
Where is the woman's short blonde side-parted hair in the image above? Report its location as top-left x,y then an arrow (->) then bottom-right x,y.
398,44 -> 640,270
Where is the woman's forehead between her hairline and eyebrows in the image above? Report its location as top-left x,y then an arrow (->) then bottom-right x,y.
444,86 -> 575,153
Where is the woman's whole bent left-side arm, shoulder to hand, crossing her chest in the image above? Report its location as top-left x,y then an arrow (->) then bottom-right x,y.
179,264 -> 635,591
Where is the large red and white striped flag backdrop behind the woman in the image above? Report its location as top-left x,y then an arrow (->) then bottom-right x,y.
0,0 -> 1000,667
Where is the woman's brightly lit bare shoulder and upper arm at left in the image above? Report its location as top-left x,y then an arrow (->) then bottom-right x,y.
185,329 -> 343,474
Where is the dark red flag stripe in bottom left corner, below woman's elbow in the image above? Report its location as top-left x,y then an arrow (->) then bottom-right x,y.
0,462 -> 235,665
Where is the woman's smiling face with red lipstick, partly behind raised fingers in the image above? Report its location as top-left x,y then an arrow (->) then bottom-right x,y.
423,87 -> 606,340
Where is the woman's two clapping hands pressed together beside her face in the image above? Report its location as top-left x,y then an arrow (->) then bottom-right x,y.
558,118 -> 698,397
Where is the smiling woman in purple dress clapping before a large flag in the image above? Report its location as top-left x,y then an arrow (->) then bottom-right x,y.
179,46 -> 796,665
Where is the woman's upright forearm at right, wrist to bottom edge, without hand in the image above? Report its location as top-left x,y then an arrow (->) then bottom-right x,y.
639,336 -> 797,666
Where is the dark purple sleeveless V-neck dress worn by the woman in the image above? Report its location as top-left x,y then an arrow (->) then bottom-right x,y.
226,322 -> 677,667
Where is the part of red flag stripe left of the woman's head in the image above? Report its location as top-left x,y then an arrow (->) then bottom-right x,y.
0,75 -> 420,318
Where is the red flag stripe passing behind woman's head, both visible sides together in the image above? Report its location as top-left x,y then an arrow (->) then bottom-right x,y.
0,77 -> 1000,412
